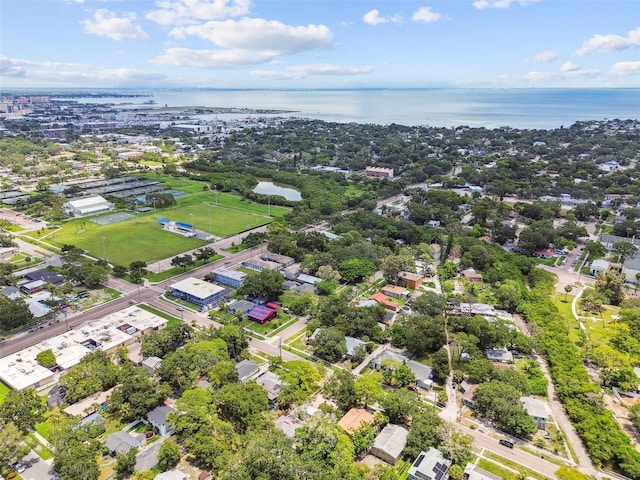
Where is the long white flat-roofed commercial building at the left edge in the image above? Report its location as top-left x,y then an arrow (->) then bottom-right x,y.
0,306 -> 167,390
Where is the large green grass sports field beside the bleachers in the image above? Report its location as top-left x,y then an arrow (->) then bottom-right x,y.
45,192 -> 289,265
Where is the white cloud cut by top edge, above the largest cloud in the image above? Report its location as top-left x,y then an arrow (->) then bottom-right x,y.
147,0 -> 251,25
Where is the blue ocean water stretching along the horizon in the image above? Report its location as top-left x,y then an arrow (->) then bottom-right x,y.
58,88 -> 640,129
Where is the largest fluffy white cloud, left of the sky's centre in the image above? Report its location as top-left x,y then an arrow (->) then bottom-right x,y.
153,18 -> 333,68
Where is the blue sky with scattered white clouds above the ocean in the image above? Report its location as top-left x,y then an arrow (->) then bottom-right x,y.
0,0 -> 640,89
